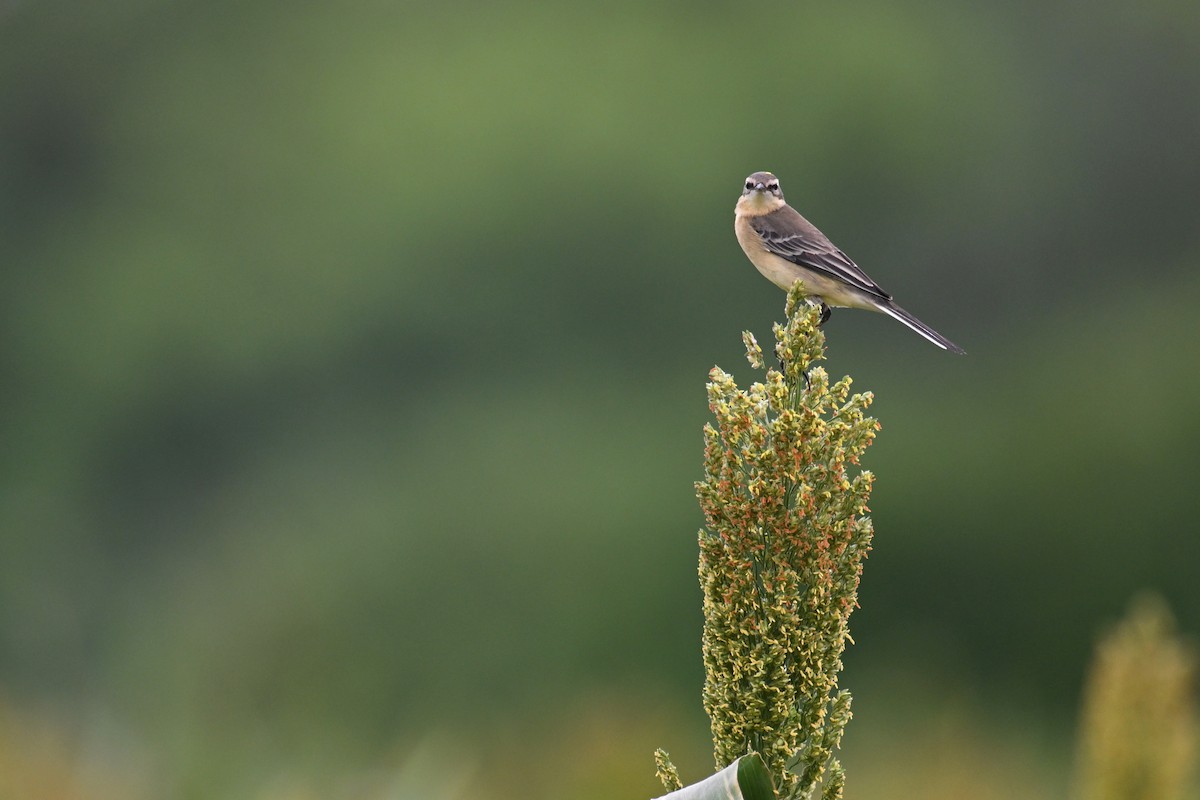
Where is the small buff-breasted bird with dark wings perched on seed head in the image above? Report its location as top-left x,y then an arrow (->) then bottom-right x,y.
733,173 -> 966,355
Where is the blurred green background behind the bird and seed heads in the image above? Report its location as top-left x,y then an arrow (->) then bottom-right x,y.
0,0 -> 1200,800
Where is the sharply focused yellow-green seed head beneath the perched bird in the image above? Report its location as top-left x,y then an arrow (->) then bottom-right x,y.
696,289 -> 878,800
